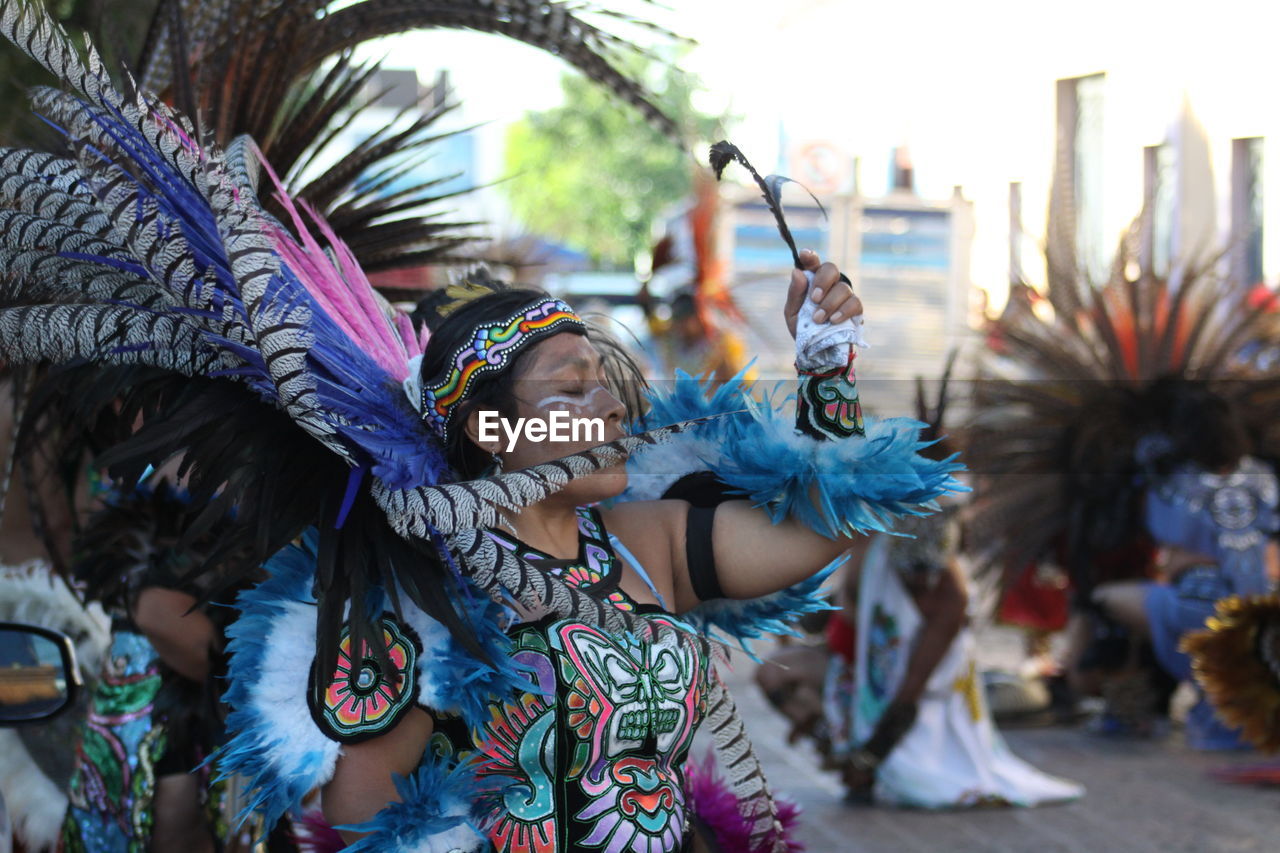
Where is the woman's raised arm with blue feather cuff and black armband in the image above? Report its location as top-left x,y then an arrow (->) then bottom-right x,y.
609,251 -> 964,611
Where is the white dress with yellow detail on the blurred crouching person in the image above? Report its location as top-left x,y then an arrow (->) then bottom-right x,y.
851,535 -> 1084,808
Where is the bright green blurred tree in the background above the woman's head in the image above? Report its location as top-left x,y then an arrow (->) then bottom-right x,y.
503,57 -> 723,269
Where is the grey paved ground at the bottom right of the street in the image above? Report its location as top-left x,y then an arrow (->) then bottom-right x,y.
731,637 -> 1280,853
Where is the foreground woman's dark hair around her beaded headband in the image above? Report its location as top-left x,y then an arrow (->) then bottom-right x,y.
421,287 -> 645,479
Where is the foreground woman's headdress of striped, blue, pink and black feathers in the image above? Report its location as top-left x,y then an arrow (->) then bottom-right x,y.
0,0 -> 706,669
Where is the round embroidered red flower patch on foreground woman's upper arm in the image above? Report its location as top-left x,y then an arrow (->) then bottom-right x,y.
307,613 -> 422,743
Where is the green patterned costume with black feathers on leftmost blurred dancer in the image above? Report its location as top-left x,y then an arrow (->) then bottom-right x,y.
60,483 -> 247,853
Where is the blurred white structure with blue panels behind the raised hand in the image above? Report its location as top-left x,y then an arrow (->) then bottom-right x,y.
717,149 -> 975,415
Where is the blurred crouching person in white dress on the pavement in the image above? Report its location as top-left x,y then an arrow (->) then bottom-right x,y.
827,512 -> 1084,808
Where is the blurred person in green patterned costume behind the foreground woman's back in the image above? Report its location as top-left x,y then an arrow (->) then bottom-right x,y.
63,482 -> 252,853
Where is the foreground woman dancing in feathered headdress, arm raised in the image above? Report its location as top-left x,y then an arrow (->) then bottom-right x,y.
0,0 -> 957,850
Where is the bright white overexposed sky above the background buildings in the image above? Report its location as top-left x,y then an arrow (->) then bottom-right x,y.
358,0 -> 1280,301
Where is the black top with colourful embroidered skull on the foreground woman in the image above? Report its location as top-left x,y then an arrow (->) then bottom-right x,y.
433,510 -> 709,853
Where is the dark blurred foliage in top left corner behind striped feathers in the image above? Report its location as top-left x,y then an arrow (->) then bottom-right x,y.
0,0 -> 159,149
